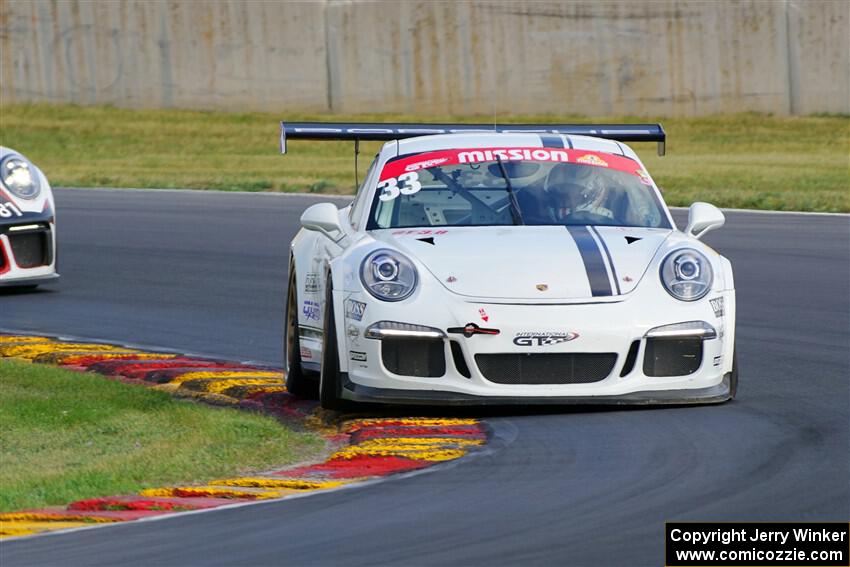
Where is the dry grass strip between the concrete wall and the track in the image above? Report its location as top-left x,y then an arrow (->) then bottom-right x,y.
0,105 -> 850,212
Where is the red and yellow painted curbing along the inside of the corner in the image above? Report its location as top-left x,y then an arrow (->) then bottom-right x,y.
0,335 -> 487,539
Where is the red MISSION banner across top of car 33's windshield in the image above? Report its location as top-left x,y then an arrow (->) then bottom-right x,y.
380,147 -> 652,185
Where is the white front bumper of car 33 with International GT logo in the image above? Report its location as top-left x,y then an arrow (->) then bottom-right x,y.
335,278 -> 735,405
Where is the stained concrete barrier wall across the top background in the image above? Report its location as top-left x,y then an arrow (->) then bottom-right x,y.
0,0 -> 850,116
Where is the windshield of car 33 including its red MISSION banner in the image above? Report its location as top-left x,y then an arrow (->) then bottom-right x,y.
367,147 -> 670,234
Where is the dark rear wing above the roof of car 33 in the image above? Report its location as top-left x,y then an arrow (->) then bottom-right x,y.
280,122 -> 667,156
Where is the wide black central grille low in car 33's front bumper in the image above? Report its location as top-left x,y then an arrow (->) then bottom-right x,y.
475,352 -> 617,385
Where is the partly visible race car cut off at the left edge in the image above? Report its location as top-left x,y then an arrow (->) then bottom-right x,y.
0,146 -> 59,288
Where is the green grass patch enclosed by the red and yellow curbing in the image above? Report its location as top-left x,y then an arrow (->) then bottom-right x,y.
0,360 -> 324,512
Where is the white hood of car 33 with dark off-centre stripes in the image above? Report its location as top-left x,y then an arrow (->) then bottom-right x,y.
373,226 -> 671,301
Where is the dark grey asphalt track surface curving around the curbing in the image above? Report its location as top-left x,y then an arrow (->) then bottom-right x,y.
0,190 -> 850,567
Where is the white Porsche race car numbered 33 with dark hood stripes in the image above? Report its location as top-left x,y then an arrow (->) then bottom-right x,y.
281,123 -> 737,408
